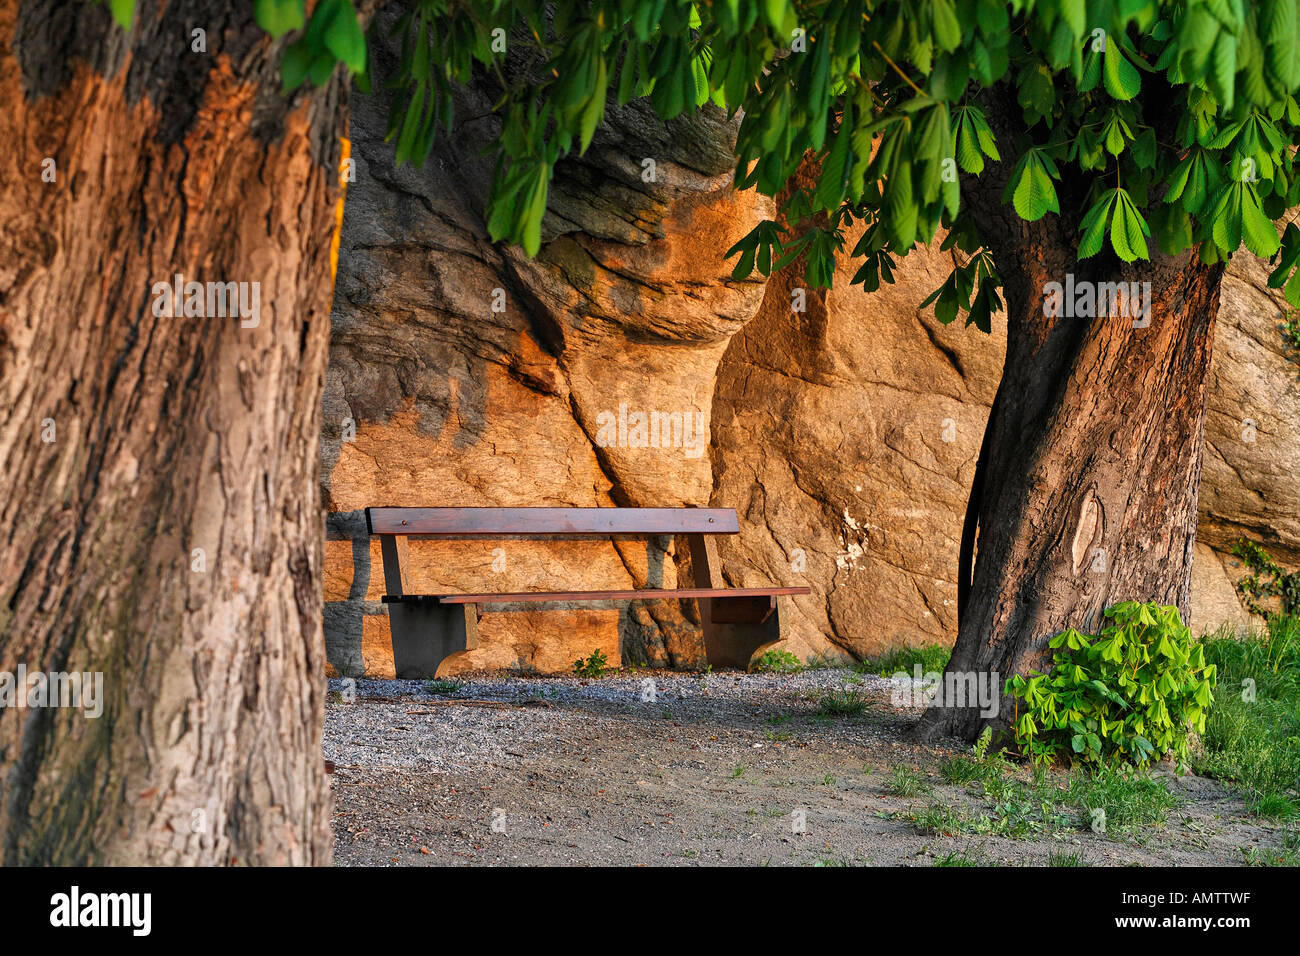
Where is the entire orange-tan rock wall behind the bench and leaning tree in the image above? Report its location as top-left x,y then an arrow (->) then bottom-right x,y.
322,72 -> 1300,676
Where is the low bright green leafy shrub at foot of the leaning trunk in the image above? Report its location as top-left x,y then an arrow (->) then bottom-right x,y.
1008,601 -> 1216,766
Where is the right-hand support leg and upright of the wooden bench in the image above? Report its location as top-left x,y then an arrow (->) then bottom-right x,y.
686,535 -> 781,670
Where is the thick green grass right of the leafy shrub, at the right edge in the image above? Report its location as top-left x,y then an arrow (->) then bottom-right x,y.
1191,614 -> 1300,819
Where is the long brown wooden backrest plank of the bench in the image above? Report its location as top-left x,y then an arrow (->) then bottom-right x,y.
365,507 -> 740,537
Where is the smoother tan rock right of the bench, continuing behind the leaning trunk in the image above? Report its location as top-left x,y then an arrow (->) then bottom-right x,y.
711,243 -> 1300,657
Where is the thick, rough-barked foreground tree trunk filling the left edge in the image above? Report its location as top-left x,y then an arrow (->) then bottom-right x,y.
0,0 -> 346,865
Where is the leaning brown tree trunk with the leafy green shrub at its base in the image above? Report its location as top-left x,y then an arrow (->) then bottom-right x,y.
918,89 -> 1223,740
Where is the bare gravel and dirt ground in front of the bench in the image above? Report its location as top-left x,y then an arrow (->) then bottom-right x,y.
324,669 -> 1283,866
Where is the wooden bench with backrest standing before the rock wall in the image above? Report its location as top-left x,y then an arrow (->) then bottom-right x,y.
365,507 -> 810,678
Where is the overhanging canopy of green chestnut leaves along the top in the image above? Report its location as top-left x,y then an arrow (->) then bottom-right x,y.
244,0 -> 1300,328
